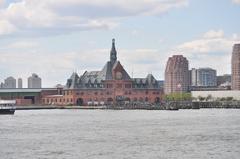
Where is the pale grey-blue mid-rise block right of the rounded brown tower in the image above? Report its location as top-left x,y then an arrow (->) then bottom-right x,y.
191,68 -> 217,87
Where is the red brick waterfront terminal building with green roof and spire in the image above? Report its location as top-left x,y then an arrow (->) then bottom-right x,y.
42,39 -> 163,105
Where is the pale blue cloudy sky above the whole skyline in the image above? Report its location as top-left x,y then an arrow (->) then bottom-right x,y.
0,0 -> 240,87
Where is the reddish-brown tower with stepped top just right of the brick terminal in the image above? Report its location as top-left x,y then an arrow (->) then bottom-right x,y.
164,55 -> 190,94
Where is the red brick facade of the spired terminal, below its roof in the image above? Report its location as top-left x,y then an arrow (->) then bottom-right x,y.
42,64 -> 163,105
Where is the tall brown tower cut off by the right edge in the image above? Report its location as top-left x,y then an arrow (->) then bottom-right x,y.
232,44 -> 240,90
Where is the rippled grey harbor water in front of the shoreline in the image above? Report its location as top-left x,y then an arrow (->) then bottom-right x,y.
0,109 -> 240,159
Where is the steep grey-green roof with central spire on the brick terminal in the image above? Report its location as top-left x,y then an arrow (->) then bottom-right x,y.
65,39 -> 161,89
